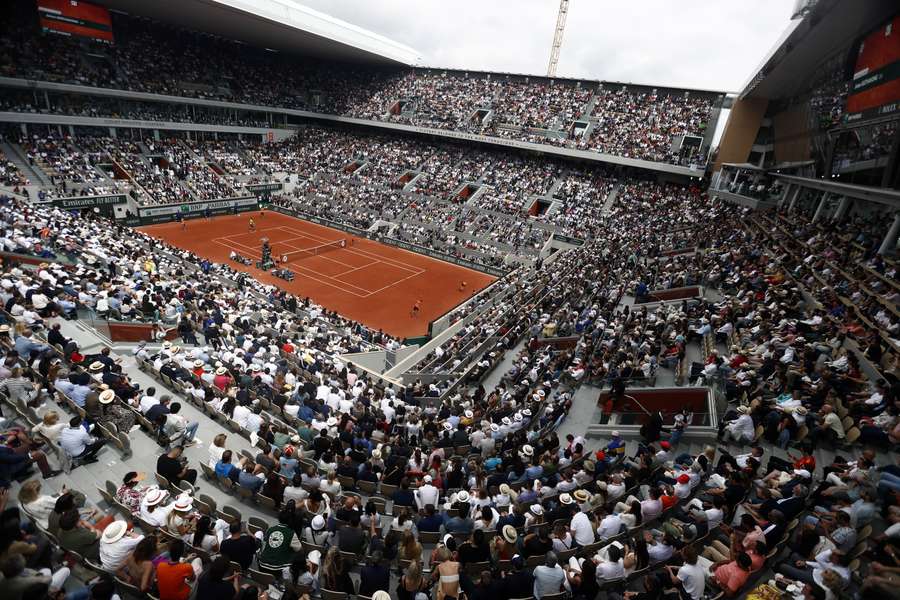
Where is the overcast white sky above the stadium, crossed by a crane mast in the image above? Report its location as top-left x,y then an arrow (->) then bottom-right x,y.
297,0 -> 794,91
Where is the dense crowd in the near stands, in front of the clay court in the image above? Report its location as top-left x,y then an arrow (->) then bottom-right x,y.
0,177 -> 900,600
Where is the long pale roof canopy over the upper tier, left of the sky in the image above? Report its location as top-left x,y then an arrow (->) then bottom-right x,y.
99,0 -> 419,65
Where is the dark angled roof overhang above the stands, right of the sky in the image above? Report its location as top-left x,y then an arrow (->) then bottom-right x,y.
740,0 -> 897,99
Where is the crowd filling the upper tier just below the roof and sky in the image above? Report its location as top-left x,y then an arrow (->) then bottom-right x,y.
2,0 -> 713,163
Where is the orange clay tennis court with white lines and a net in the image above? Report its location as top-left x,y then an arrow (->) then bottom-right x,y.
137,211 -> 495,337
